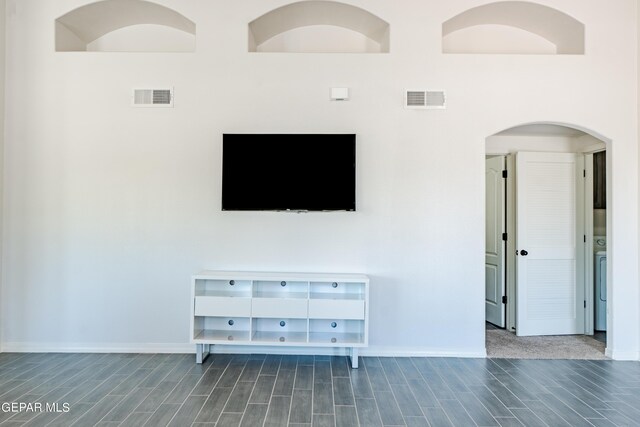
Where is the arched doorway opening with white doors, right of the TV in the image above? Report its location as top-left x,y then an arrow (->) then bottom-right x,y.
485,122 -> 611,358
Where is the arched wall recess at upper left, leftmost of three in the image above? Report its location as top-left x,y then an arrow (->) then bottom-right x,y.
55,0 -> 196,52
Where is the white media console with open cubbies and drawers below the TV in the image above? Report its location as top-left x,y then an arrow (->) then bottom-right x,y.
191,271 -> 369,368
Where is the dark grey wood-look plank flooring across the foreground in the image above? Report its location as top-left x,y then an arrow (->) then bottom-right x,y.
0,354 -> 640,427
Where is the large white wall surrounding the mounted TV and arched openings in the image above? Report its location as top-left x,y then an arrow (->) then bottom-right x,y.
1,0 -> 640,358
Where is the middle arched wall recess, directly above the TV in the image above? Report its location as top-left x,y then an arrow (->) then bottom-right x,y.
249,0 -> 389,53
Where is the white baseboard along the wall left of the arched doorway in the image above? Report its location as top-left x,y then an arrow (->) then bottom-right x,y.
2,342 -> 487,358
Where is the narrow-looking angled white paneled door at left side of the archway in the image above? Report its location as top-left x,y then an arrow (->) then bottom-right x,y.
484,157 -> 505,328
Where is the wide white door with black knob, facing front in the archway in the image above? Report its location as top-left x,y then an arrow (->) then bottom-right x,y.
516,152 -> 585,336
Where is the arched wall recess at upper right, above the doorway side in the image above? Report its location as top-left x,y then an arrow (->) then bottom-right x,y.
442,1 -> 585,55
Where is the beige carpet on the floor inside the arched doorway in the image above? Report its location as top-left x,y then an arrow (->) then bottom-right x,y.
486,329 -> 607,360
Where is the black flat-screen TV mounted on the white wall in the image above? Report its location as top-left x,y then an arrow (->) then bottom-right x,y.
222,134 -> 356,211
